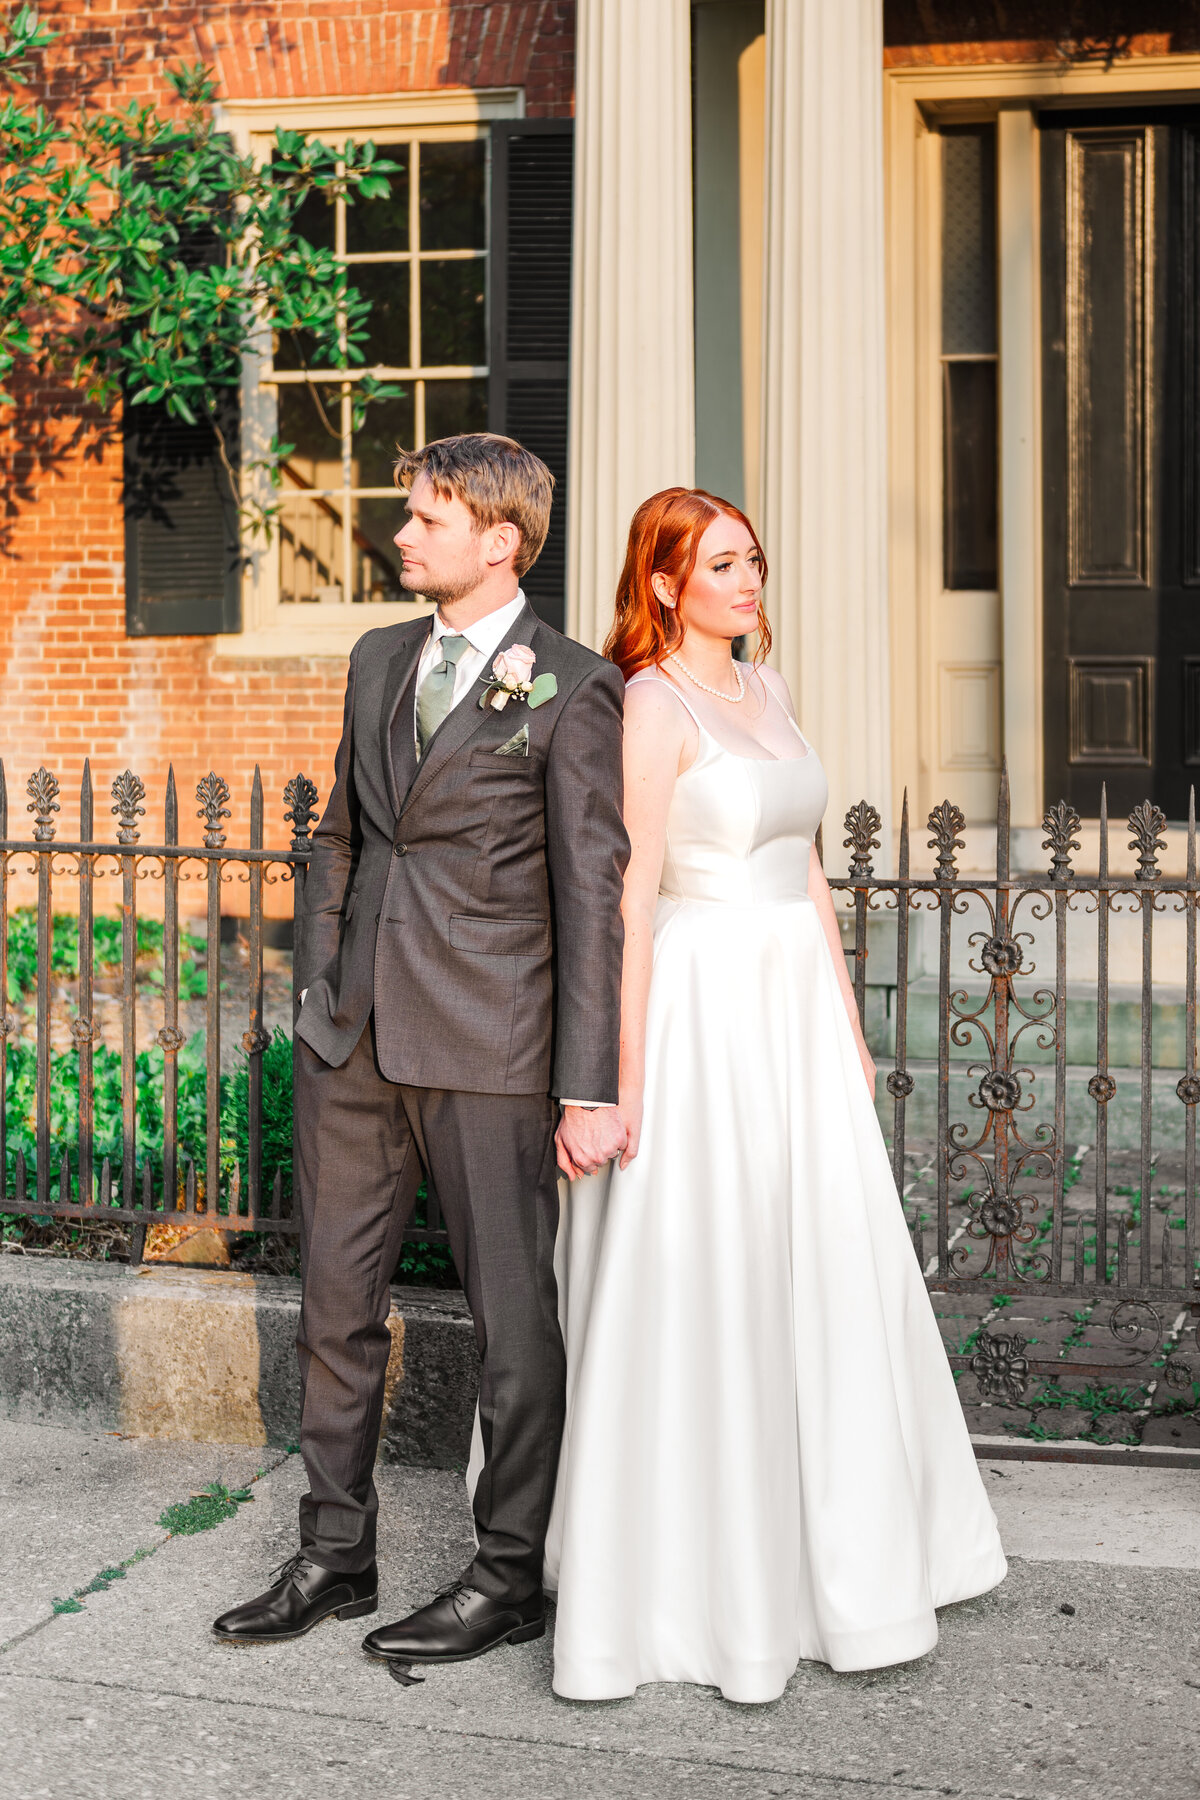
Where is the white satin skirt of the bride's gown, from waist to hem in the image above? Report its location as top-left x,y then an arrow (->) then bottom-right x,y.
545,900 -> 1006,1701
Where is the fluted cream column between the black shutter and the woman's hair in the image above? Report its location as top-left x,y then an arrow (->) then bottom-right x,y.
567,0 -> 698,646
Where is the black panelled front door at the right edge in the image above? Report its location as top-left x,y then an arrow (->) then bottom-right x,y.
1040,108 -> 1200,819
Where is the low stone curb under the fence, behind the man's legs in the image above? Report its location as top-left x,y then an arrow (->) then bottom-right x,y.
0,1255 -> 479,1469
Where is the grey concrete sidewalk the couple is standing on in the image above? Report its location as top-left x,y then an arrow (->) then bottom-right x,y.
0,1426 -> 1200,1800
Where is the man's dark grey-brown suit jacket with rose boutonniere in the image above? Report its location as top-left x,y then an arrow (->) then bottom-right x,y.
297,607 -> 630,1100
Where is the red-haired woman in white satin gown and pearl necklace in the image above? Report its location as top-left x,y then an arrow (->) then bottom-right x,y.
547,488 -> 1006,1701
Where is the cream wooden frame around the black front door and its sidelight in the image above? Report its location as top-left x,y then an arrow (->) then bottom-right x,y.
883,56 -> 1200,866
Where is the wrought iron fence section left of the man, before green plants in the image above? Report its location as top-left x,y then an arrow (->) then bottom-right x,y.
0,761 -> 455,1262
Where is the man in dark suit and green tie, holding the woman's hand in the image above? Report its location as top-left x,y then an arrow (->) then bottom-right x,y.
214,434 -> 628,1663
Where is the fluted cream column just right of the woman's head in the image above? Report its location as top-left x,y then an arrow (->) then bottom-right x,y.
763,0 -> 891,868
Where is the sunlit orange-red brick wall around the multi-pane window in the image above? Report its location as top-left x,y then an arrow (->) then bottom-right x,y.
0,0 -> 574,896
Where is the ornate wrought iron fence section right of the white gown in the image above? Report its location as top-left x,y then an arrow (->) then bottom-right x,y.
831,772 -> 1200,1442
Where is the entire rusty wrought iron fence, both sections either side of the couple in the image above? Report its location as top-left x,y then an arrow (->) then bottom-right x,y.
0,765 -> 1200,1404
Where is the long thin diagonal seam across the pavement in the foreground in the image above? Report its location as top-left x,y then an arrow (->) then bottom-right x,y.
0,1669 -> 1045,1800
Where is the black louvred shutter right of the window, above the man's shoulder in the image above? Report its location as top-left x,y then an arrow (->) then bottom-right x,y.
488,119 -> 574,632
